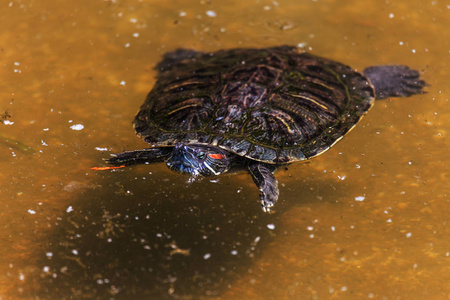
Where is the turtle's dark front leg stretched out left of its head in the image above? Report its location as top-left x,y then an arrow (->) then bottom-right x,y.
105,147 -> 172,166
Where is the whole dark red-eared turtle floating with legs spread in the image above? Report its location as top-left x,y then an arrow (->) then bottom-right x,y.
97,45 -> 427,212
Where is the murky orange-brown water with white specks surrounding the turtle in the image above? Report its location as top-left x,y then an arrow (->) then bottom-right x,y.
0,0 -> 450,300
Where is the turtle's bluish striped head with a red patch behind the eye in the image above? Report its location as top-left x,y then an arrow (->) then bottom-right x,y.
167,143 -> 233,177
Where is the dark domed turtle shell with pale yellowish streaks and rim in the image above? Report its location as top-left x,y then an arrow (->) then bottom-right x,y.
134,46 -> 375,164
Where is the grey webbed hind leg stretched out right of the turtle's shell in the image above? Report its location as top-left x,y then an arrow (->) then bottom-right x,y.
363,65 -> 427,100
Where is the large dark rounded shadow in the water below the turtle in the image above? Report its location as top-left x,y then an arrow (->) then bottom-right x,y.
39,172 -> 272,298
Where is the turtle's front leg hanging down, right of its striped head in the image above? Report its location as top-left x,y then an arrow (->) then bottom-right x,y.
248,162 -> 280,212
